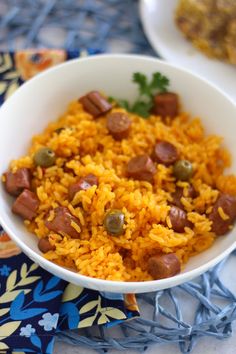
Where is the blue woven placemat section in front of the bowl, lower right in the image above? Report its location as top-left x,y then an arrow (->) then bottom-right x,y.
57,251 -> 236,354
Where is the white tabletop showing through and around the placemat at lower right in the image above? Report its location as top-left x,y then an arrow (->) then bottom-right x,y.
54,256 -> 236,354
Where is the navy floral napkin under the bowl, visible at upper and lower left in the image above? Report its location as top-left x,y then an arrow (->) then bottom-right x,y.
0,49 -> 139,354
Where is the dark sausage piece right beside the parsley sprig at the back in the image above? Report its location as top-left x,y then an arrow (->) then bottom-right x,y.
153,92 -> 179,118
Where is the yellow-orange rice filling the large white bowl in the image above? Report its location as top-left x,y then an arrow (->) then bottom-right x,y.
8,102 -> 236,281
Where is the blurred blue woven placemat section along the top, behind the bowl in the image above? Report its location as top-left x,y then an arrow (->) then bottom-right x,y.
0,0 -> 154,55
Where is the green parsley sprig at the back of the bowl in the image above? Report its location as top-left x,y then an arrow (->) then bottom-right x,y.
109,72 -> 169,118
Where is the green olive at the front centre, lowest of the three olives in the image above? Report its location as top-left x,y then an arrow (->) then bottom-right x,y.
104,210 -> 125,236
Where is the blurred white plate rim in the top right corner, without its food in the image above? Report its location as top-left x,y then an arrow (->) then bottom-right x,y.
140,0 -> 236,101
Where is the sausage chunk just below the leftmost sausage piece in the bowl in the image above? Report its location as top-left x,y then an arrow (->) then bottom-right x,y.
12,189 -> 39,220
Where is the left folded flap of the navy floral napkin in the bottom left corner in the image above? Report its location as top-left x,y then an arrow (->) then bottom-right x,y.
0,233 -> 65,353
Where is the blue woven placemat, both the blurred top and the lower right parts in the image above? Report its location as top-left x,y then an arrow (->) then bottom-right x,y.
0,0 -> 236,353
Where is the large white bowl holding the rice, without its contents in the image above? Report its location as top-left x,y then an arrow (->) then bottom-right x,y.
0,55 -> 236,293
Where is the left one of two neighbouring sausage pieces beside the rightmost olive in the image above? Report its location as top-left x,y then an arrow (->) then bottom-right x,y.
127,155 -> 156,183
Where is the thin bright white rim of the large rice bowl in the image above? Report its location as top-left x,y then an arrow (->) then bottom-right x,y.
0,54 -> 236,293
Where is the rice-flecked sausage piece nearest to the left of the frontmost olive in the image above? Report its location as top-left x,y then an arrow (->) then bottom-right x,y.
45,207 -> 80,238
